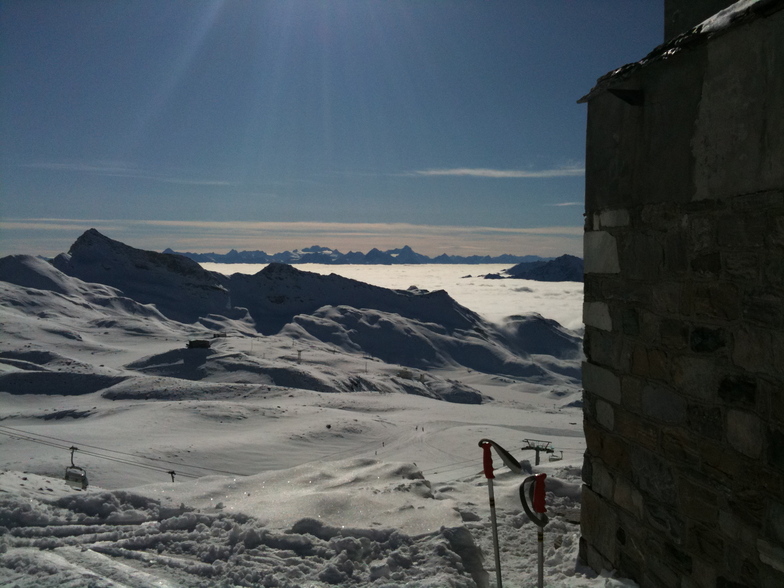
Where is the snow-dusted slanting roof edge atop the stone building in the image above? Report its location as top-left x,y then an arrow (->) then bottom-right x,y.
577,0 -> 784,104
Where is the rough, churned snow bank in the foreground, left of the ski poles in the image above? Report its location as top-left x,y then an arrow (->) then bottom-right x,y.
0,472 -> 486,588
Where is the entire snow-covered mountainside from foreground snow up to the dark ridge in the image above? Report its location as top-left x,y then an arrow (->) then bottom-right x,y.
0,235 -> 632,588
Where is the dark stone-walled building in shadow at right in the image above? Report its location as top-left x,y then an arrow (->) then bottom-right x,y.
581,0 -> 784,588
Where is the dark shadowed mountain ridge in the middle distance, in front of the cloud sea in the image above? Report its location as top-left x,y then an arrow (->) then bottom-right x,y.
0,229 -> 581,389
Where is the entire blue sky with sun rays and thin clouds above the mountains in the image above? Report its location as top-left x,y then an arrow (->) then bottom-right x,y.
0,0 -> 664,256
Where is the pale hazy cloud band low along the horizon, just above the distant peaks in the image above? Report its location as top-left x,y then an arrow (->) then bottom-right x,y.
0,219 -> 583,256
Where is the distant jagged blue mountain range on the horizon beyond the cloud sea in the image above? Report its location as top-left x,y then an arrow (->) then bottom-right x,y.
163,245 -> 551,265
